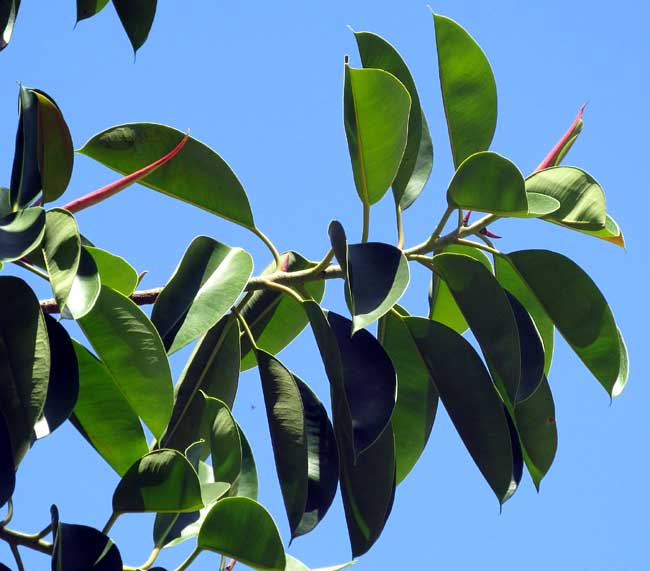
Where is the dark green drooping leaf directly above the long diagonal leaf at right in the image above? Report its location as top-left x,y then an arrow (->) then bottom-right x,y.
433,254 -> 521,404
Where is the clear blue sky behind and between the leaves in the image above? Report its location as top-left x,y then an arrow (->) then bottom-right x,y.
0,0 -> 650,571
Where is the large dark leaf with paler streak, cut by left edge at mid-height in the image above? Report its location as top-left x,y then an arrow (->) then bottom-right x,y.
0,276 -> 50,466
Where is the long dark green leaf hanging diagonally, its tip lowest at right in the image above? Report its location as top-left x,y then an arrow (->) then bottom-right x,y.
405,317 -> 515,503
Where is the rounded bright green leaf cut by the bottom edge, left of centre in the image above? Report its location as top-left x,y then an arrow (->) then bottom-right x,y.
197,498 -> 286,571
